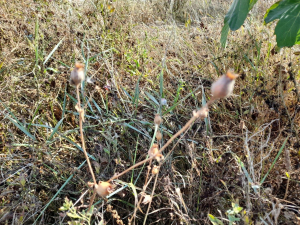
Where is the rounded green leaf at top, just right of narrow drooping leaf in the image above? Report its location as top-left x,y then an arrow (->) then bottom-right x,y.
224,0 -> 250,31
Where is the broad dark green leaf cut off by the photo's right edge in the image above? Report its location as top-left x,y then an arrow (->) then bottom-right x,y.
275,1 -> 300,47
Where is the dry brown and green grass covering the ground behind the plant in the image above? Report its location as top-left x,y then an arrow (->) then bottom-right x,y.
0,0 -> 300,224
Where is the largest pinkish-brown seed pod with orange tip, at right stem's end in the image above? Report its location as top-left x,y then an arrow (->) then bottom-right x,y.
211,71 -> 238,99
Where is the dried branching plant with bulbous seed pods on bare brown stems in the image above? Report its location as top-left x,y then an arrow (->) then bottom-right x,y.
70,67 -> 238,220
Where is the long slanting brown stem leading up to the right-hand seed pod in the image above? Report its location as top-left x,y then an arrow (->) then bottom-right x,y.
107,98 -> 216,182
